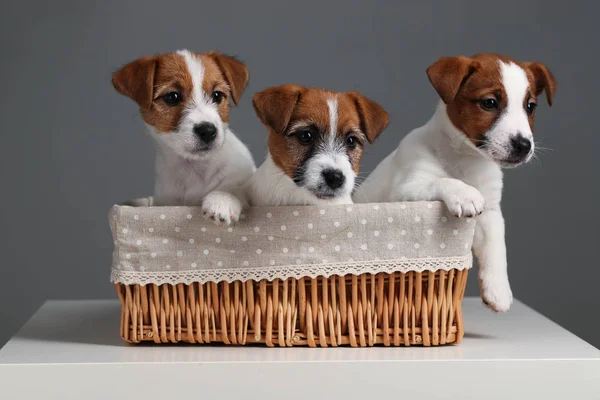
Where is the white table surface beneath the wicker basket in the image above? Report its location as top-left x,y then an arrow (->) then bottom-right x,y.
0,298 -> 600,400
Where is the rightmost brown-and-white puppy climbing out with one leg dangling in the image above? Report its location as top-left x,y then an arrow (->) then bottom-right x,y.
355,54 -> 556,311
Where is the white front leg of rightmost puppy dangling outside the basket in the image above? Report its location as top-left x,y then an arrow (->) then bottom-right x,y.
473,209 -> 513,312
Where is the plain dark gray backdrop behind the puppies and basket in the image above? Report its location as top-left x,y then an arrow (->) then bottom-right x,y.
0,0 -> 600,346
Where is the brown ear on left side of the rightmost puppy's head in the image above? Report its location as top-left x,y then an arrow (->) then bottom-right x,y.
427,56 -> 479,104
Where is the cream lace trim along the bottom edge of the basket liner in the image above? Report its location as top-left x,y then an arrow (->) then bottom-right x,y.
110,254 -> 473,285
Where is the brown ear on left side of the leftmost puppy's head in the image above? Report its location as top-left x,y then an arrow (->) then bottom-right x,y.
112,56 -> 158,108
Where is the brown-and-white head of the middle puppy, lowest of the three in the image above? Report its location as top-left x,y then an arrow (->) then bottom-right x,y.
252,85 -> 389,199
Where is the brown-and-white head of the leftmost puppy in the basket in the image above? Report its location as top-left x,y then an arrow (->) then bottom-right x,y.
112,50 -> 248,159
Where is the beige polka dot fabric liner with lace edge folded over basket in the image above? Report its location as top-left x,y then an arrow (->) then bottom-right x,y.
109,198 -> 476,285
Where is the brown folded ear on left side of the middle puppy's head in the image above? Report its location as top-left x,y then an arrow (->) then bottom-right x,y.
252,84 -> 304,133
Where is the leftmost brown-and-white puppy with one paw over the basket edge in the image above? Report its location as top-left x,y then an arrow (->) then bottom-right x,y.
112,50 -> 256,224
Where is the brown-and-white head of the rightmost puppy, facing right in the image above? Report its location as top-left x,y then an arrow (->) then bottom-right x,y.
427,54 -> 556,167
